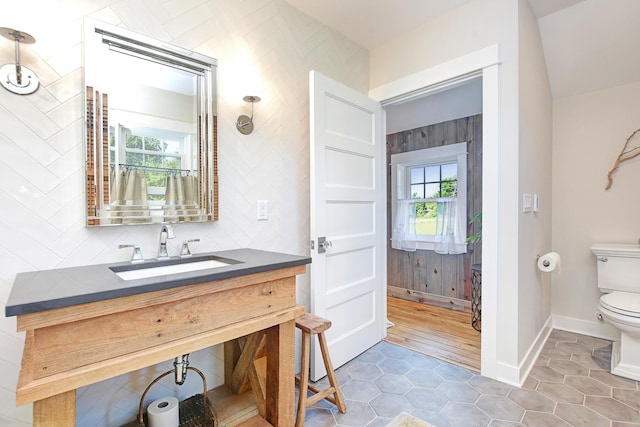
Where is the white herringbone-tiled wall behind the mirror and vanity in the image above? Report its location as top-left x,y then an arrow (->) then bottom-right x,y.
0,0 -> 369,426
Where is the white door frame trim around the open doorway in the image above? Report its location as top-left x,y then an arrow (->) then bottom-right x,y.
369,45 -> 500,378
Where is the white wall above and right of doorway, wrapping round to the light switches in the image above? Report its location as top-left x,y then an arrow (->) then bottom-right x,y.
371,0 -> 551,384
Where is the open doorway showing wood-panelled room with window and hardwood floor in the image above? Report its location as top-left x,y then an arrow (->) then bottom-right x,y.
384,76 -> 483,371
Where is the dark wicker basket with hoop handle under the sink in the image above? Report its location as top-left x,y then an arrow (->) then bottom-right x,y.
138,366 -> 218,427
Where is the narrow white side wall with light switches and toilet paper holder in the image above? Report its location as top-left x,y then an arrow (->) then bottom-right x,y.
513,0 -> 553,381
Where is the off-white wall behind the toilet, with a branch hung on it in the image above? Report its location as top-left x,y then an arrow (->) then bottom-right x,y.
552,82 -> 640,338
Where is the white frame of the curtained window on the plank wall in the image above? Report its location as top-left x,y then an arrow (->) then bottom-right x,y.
391,142 -> 467,250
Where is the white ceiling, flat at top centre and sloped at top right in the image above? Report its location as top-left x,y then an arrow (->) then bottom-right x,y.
286,0 -> 640,98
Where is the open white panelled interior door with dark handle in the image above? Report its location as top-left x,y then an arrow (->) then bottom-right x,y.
309,71 -> 387,381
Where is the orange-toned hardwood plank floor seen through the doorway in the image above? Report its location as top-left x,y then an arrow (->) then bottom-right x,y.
385,297 -> 480,372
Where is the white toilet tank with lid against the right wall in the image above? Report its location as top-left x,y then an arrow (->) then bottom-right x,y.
591,243 -> 640,293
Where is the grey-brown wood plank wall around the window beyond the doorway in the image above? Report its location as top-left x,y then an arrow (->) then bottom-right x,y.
387,114 -> 482,311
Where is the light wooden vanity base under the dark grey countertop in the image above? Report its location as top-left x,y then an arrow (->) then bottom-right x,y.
16,265 -> 306,427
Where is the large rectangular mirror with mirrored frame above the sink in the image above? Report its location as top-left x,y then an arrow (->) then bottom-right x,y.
84,18 -> 218,226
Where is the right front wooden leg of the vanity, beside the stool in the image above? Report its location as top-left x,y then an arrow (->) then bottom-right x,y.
265,319 -> 296,427
